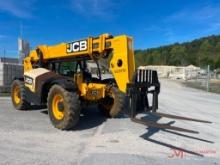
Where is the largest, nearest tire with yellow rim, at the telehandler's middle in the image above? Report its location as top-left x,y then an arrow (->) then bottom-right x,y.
47,85 -> 81,130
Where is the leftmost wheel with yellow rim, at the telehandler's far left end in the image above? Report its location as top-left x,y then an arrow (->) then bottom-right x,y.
11,80 -> 31,110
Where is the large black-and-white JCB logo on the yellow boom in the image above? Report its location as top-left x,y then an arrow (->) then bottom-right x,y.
66,40 -> 87,53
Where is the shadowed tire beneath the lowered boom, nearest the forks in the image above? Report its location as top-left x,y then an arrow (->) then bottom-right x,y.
98,87 -> 125,118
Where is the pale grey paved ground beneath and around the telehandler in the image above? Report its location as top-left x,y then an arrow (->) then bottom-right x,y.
0,80 -> 220,165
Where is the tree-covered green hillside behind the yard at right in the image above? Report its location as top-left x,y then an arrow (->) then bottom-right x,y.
135,35 -> 220,69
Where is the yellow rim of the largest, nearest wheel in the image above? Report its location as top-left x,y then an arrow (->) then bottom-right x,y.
52,94 -> 64,120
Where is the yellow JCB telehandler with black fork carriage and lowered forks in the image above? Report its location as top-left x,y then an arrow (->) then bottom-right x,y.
11,34 -> 210,132
